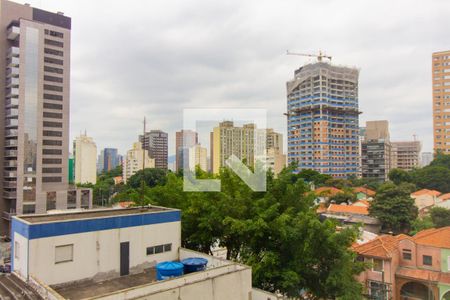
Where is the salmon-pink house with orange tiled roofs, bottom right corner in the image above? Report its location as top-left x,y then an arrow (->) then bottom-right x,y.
353,227 -> 450,300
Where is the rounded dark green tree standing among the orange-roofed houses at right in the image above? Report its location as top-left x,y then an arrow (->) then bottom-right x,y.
369,182 -> 418,234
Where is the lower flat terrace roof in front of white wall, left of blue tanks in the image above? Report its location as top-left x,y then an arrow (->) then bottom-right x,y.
50,267 -> 156,300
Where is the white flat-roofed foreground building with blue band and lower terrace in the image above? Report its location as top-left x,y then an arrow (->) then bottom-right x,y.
11,206 -> 281,300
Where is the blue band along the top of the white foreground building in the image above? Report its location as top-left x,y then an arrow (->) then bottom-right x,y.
12,211 -> 181,240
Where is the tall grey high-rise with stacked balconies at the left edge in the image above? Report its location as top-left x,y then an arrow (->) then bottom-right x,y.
0,0 -> 91,233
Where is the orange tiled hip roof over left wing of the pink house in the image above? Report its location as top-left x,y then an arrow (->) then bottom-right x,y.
352,235 -> 398,258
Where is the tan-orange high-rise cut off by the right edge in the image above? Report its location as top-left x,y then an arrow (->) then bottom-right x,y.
432,50 -> 450,154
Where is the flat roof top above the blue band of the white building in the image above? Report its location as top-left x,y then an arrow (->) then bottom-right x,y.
17,206 -> 176,224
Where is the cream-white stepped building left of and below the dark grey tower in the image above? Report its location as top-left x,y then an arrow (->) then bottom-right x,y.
122,142 -> 155,183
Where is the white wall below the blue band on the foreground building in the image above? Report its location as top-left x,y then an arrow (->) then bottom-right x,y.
26,222 -> 181,285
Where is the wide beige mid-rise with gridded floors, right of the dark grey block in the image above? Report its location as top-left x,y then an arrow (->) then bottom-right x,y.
392,141 -> 422,171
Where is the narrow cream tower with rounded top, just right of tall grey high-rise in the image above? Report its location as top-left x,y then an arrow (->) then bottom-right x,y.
73,134 -> 97,184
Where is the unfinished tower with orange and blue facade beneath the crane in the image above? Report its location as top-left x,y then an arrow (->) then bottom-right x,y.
287,62 -> 360,178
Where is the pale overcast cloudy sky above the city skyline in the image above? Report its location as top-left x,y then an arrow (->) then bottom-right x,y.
19,0 -> 450,154
